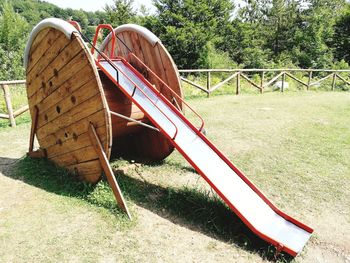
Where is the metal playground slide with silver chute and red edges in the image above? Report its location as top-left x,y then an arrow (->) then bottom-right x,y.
96,60 -> 313,256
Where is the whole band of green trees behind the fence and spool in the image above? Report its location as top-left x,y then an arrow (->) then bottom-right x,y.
0,0 -> 350,80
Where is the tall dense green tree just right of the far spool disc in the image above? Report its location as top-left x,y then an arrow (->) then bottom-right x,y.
153,0 -> 233,68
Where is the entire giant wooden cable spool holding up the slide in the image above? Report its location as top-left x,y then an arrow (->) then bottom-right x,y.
25,18 -> 182,186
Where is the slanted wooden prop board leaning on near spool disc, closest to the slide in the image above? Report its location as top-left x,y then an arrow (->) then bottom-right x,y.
89,124 -> 131,219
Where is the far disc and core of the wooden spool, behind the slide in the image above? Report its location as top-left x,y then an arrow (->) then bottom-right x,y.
100,24 -> 183,160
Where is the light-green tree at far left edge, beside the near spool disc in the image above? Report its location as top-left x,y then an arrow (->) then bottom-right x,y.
0,1 -> 28,80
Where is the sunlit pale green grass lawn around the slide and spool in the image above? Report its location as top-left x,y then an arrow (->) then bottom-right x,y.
0,92 -> 350,262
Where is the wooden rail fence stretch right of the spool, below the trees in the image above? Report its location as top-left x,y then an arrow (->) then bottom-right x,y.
179,69 -> 350,97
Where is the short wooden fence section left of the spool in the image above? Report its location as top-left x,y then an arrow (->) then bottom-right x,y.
0,80 -> 28,127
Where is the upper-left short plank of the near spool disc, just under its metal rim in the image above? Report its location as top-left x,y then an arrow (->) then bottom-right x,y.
27,28 -> 64,73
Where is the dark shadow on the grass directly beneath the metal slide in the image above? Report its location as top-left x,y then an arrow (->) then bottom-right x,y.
117,171 -> 293,262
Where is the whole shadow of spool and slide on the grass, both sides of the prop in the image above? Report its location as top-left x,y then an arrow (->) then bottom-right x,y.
0,157 -> 292,262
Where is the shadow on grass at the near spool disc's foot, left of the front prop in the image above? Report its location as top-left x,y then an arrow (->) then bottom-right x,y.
0,157 -> 131,221
